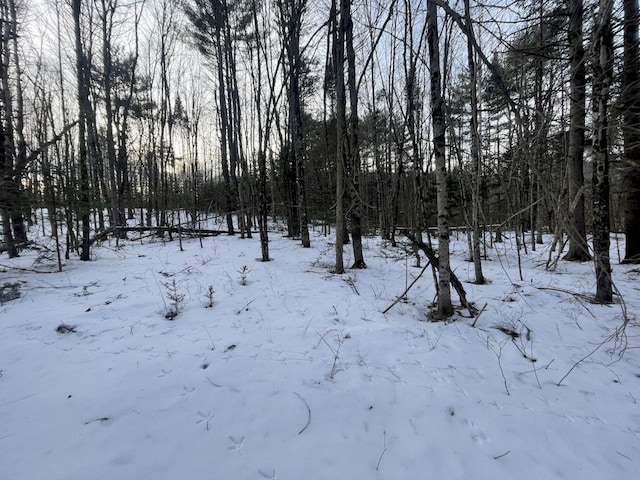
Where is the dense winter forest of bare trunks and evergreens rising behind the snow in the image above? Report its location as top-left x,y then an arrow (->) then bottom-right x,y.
0,0 -> 640,318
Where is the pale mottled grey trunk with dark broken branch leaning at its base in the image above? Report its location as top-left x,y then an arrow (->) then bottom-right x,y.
427,0 -> 453,317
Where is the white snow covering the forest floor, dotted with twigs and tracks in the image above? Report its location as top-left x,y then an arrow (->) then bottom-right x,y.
0,226 -> 640,480
